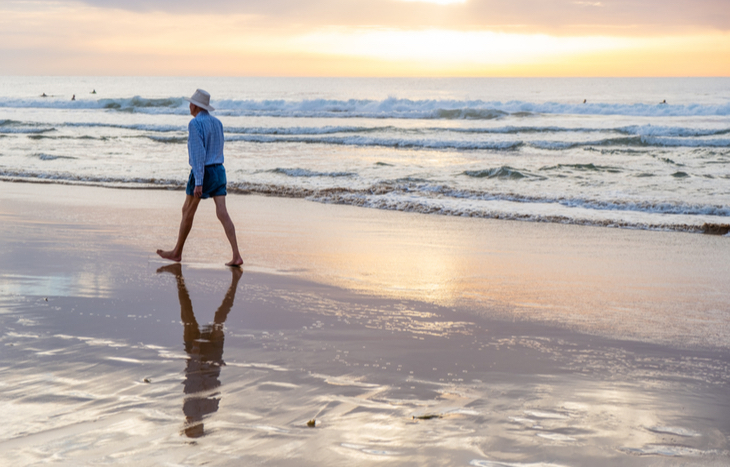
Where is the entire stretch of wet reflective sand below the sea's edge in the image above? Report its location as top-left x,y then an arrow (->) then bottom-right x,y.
0,182 -> 730,466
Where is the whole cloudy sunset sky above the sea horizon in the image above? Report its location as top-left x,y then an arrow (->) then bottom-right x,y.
0,0 -> 730,77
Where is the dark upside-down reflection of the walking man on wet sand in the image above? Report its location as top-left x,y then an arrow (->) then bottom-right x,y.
157,264 -> 242,438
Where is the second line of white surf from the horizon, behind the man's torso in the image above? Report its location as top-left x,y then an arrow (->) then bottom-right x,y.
0,119 -> 730,151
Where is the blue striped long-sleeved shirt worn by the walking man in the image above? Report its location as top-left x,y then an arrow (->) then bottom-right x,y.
188,110 -> 223,186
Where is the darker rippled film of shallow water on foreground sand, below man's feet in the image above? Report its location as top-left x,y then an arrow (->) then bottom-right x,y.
0,264 -> 730,466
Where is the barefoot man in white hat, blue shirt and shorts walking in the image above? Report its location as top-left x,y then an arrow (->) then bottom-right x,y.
157,89 -> 243,267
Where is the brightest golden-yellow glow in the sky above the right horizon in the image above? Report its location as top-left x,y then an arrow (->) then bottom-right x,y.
291,29 -> 730,76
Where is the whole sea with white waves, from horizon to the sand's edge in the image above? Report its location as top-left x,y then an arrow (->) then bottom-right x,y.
0,77 -> 730,232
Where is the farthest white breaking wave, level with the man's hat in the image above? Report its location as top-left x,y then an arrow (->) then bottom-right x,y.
0,96 -> 730,120
